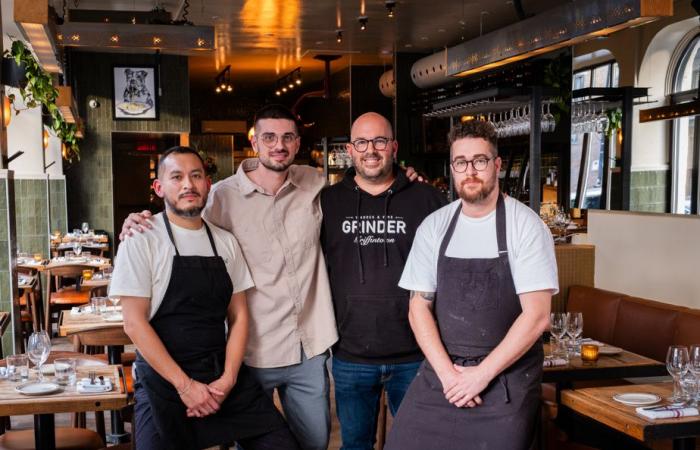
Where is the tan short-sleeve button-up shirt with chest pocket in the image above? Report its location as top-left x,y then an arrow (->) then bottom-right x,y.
204,159 -> 338,368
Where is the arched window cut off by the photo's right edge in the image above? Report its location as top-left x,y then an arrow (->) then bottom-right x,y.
671,35 -> 700,214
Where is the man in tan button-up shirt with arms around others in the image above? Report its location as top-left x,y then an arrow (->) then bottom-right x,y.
122,105 -> 338,450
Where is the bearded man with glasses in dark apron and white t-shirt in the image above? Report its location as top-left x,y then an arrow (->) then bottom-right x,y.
386,121 -> 558,450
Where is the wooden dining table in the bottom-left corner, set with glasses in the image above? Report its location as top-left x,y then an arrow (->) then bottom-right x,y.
0,352 -> 127,450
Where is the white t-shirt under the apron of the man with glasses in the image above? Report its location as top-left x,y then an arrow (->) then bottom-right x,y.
399,197 -> 559,294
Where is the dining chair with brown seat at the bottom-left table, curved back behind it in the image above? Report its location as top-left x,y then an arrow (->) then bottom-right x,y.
0,352 -> 106,450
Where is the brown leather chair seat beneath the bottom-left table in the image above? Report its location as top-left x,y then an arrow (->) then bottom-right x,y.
0,427 -> 104,450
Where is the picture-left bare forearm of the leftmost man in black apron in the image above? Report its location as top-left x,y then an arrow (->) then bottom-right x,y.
124,321 -> 190,391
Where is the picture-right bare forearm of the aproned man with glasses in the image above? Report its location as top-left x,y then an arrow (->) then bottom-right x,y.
480,292 -> 551,379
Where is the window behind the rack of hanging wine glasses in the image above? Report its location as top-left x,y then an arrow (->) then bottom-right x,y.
571,61 -> 620,208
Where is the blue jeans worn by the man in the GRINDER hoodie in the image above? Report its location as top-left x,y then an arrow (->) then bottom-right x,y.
332,357 -> 422,450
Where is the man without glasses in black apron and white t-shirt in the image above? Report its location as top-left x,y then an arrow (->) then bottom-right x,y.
110,147 -> 298,450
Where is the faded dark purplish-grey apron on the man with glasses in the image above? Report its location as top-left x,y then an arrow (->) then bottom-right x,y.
386,195 -> 543,450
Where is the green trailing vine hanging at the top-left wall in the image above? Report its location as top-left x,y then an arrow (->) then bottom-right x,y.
3,40 -> 80,162
